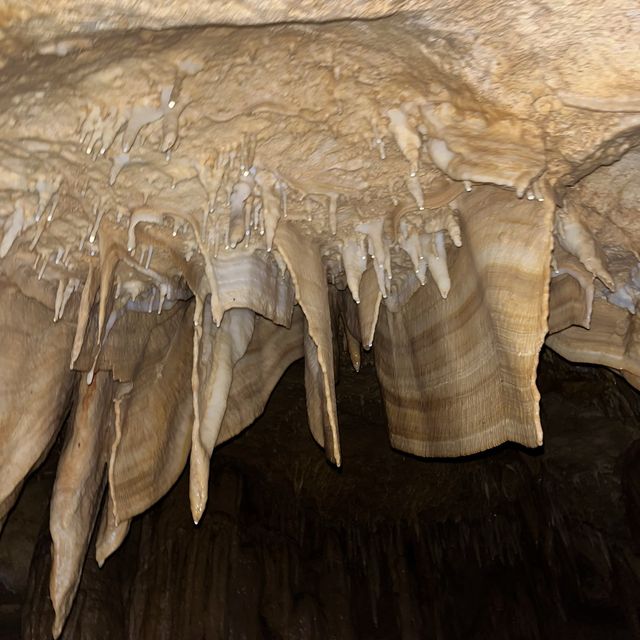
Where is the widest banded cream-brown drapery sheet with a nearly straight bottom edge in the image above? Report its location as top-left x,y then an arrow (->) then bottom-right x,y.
374,187 -> 553,456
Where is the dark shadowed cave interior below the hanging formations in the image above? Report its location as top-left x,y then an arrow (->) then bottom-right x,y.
0,349 -> 640,640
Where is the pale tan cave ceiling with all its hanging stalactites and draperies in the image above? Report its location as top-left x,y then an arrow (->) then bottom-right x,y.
0,0 -> 640,634
